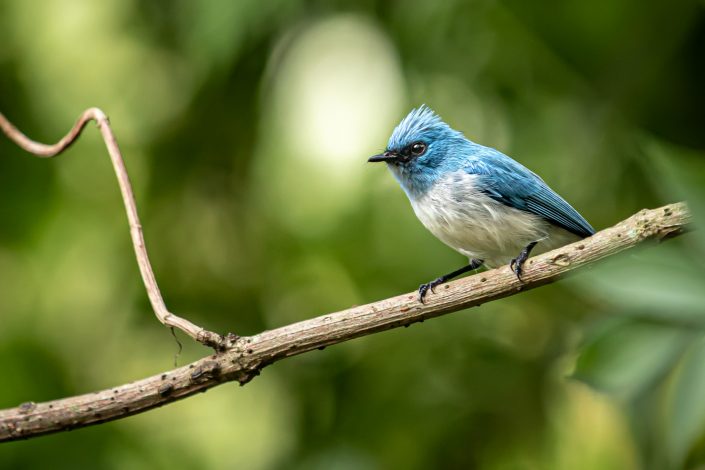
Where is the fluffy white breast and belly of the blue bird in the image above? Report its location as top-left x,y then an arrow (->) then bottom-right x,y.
409,171 -> 579,267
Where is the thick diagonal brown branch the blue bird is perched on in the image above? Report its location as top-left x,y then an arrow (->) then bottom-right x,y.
0,203 -> 690,441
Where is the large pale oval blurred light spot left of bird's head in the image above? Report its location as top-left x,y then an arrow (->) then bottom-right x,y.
257,15 -> 405,235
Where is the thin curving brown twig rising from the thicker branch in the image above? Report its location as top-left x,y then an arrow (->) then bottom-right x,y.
0,108 -> 228,350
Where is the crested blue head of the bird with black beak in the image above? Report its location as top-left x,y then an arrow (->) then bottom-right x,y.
367,105 -> 468,193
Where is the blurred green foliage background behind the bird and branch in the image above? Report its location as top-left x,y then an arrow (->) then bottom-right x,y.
0,0 -> 705,470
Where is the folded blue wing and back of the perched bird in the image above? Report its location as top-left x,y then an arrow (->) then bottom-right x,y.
465,146 -> 595,238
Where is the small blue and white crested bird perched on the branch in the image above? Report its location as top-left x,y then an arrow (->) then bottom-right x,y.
368,105 -> 595,303
